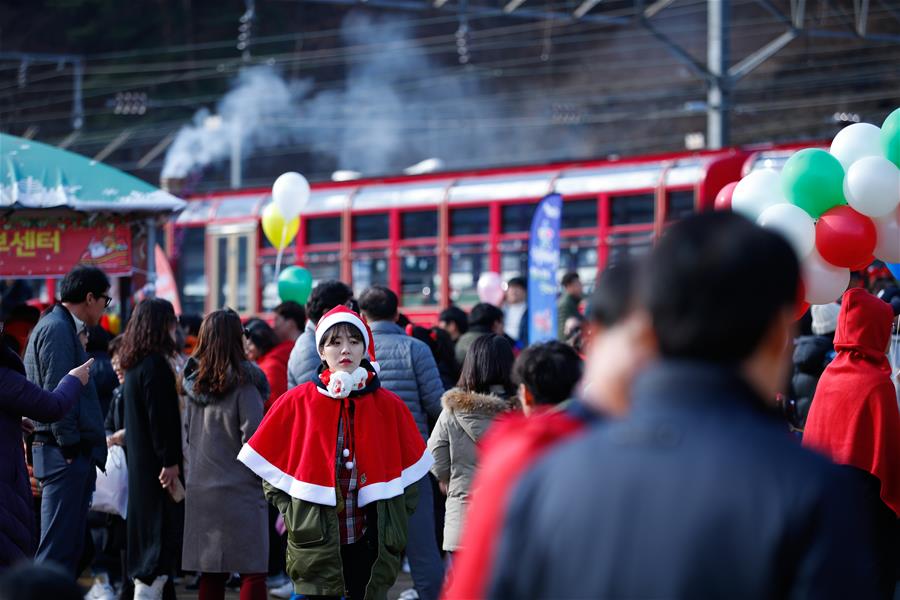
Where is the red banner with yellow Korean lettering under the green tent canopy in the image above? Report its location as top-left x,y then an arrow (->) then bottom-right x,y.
0,224 -> 131,277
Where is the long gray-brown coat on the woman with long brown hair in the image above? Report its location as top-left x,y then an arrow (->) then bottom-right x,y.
182,359 -> 269,573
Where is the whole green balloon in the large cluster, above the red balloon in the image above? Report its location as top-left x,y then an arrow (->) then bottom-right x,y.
781,148 -> 847,218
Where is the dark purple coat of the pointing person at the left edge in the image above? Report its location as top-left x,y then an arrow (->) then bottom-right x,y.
0,344 -> 81,569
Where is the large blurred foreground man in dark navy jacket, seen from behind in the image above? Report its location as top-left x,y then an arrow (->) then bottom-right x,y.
489,213 -> 875,599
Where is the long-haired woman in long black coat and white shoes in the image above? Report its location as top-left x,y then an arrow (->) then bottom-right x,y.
119,298 -> 184,599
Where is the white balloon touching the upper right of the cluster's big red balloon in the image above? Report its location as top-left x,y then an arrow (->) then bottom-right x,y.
844,156 -> 900,218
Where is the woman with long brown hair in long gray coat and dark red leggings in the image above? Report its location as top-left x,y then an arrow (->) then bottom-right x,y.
182,309 -> 269,600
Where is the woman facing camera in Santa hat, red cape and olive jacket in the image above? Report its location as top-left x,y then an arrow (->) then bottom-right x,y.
238,306 -> 433,600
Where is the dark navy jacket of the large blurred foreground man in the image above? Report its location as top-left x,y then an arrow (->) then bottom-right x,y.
490,362 -> 874,600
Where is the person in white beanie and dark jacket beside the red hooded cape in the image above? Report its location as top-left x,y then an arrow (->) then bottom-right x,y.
788,302 -> 841,432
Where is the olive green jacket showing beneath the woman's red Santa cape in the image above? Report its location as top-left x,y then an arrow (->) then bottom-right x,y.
263,481 -> 419,600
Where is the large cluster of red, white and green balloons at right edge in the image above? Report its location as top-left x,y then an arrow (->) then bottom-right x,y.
715,109 -> 900,304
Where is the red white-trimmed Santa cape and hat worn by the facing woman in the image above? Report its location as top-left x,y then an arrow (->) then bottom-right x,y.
238,307 -> 434,507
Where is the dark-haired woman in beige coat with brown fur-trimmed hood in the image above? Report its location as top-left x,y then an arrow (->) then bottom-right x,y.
428,333 -> 516,552
